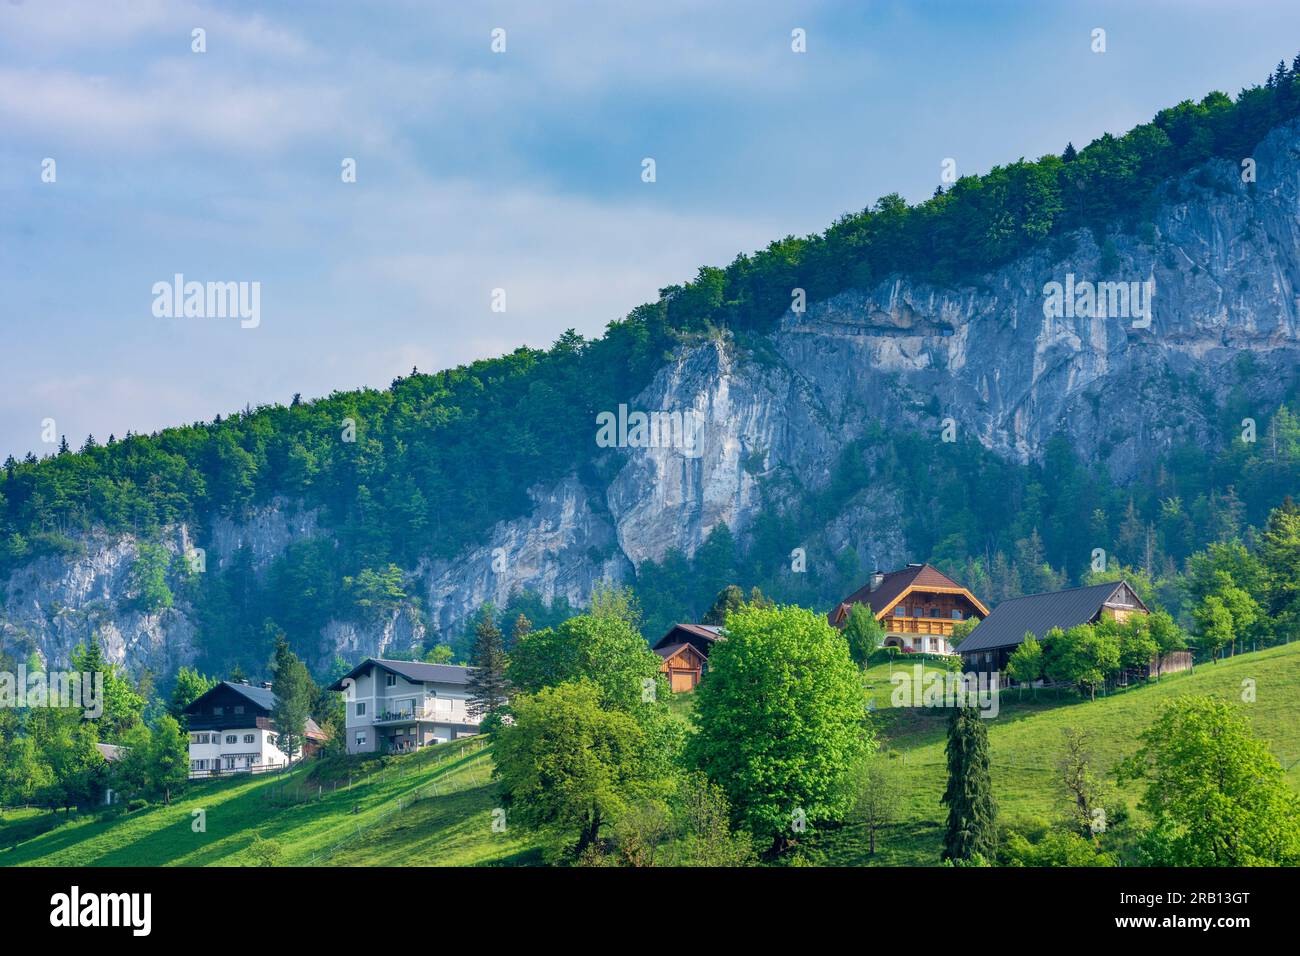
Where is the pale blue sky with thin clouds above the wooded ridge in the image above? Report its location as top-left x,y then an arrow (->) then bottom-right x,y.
0,0 -> 1300,457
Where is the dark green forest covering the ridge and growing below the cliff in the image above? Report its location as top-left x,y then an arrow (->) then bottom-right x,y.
0,59 -> 1300,671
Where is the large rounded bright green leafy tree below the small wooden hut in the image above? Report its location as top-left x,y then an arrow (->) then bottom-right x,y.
688,606 -> 874,849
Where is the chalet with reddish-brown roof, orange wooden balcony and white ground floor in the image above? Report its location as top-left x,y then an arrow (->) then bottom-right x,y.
829,564 -> 988,654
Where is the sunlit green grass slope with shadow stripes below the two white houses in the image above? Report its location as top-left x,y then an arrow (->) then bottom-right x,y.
0,740 -> 536,866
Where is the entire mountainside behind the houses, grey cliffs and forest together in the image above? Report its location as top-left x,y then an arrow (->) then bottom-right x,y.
0,68 -> 1300,675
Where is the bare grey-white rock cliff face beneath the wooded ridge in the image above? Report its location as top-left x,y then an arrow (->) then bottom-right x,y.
4,126 -> 1300,671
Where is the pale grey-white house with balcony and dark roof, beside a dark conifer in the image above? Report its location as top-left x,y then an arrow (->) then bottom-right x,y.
329,657 -> 478,753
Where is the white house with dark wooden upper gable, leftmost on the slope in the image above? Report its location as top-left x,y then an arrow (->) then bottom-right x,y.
185,680 -> 325,777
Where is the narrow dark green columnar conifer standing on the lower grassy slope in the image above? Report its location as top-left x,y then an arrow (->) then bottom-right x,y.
943,708 -> 997,862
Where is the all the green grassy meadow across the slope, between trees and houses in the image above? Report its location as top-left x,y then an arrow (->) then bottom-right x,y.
0,644 -> 1300,866
